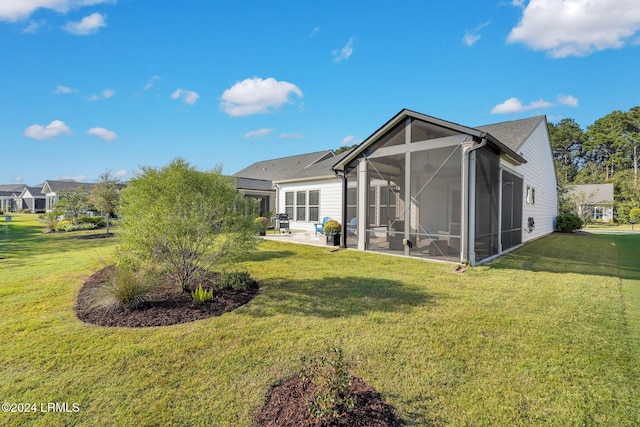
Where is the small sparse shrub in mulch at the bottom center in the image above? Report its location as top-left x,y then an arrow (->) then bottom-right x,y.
300,348 -> 355,418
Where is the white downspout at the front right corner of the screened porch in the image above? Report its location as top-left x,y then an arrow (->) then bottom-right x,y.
461,132 -> 488,265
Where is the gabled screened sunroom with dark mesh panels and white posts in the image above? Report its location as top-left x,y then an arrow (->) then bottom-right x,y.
334,110 -> 524,263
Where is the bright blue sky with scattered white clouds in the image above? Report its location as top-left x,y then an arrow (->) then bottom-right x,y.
0,0 -> 640,185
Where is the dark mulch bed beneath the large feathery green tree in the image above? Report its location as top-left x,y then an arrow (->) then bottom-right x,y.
76,267 -> 259,328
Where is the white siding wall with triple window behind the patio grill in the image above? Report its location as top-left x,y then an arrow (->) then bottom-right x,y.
274,178 -> 344,232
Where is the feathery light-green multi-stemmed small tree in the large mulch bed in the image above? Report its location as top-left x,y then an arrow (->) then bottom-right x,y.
118,159 -> 256,292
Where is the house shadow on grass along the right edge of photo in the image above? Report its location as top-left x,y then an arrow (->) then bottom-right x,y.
488,233 -> 640,280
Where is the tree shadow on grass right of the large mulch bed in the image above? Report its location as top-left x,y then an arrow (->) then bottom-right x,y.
248,276 -> 435,318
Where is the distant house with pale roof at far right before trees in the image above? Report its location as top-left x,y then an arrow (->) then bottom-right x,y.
569,184 -> 614,222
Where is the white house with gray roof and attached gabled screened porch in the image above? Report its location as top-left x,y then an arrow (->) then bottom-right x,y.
236,109 -> 558,264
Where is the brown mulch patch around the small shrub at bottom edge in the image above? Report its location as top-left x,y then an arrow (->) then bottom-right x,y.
255,376 -> 403,427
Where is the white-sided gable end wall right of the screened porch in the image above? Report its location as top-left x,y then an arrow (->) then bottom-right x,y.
513,121 -> 558,243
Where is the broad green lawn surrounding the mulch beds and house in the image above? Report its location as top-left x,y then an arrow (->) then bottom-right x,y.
0,215 -> 640,426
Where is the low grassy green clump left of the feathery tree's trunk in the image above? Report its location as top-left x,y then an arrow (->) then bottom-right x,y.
92,264 -> 158,311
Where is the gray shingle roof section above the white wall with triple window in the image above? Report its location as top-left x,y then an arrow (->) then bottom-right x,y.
233,150 -> 335,181
